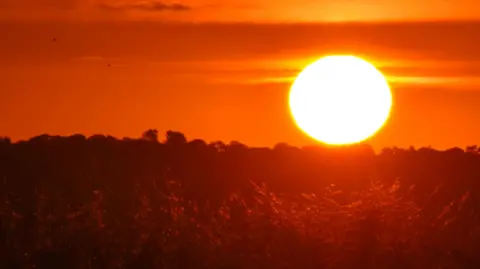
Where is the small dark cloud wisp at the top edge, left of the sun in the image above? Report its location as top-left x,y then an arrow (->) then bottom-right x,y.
100,0 -> 192,11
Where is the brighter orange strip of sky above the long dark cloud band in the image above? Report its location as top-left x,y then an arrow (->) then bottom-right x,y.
0,0 -> 480,22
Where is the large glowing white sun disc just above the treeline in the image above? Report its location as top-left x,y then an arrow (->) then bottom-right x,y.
289,55 -> 392,145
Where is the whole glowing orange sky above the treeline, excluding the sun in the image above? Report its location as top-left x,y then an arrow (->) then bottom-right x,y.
0,0 -> 480,149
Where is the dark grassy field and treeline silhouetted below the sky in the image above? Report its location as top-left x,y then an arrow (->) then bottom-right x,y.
0,130 -> 480,269
